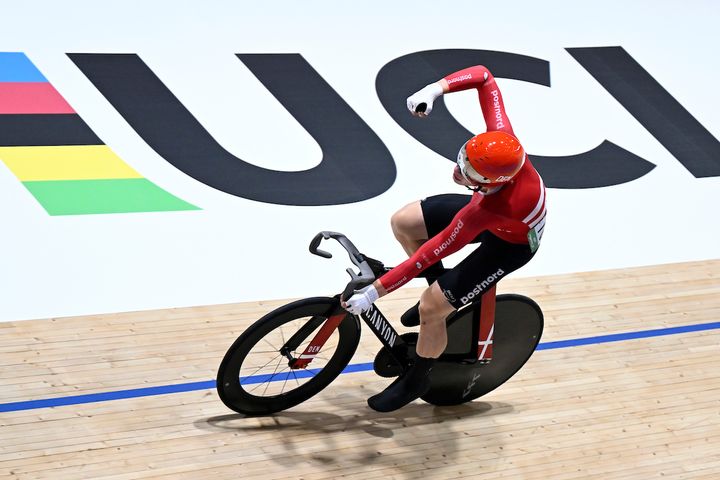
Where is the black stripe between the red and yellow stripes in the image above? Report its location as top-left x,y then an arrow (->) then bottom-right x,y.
0,113 -> 103,147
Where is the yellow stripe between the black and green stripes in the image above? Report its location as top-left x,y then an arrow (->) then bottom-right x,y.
0,145 -> 142,182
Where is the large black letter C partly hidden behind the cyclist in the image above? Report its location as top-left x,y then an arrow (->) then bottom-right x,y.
375,50 -> 655,188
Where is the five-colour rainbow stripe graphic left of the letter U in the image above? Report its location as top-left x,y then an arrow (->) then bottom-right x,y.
0,52 -> 198,215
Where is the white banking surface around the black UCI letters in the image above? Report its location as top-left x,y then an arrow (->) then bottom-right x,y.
0,0 -> 720,321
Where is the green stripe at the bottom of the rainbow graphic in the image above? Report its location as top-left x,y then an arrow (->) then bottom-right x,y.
23,178 -> 199,215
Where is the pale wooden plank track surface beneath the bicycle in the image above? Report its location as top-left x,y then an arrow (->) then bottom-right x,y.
0,260 -> 720,480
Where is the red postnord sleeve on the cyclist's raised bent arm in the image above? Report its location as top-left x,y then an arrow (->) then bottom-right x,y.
445,65 -> 515,135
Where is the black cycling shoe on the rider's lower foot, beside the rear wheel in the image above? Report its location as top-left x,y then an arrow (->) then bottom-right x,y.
368,357 -> 435,412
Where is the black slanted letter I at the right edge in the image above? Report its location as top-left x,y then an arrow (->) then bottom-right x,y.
567,47 -> 720,177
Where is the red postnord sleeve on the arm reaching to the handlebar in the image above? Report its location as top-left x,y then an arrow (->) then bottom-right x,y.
380,200 -> 493,293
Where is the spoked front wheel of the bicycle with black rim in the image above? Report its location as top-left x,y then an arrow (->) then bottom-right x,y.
216,297 -> 360,415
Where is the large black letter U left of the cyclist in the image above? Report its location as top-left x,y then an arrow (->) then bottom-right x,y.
68,54 -> 396,205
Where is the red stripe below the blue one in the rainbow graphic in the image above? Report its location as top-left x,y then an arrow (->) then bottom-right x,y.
0,82 -> 75,114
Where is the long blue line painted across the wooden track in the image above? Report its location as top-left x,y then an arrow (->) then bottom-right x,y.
0,320 -> 720,412
